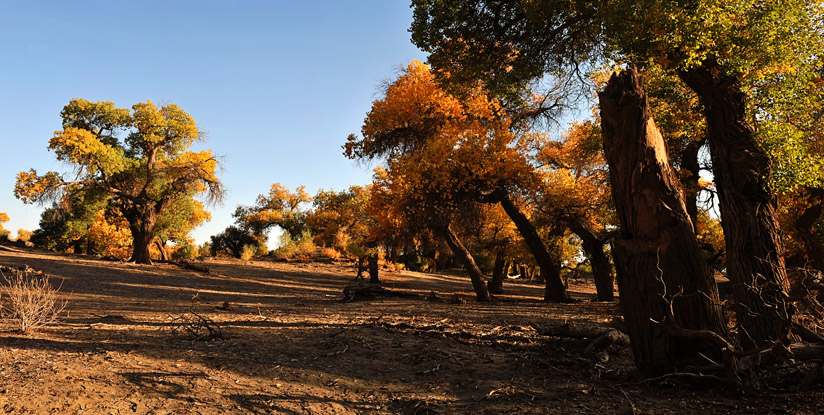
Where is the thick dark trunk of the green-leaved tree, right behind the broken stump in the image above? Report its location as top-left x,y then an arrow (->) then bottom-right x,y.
679,61 -> 795,349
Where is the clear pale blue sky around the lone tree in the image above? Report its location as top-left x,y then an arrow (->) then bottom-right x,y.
0,0 -> 425,243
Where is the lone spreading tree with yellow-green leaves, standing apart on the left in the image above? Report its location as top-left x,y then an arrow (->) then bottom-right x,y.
15,99 -> 223,263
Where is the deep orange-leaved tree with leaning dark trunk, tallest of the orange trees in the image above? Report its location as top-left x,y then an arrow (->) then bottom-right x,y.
344,61 -> 568,301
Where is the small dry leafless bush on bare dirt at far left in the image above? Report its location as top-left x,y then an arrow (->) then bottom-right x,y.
0,271 -> 67,333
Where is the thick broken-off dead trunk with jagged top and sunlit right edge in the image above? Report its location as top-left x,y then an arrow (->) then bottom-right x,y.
599,69 -> 726,375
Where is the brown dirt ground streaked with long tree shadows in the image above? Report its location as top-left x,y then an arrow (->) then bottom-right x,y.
0,246 -> 824,414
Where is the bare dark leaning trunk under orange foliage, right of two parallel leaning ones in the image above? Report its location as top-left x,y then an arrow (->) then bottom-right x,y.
498,194 -> 570,302
